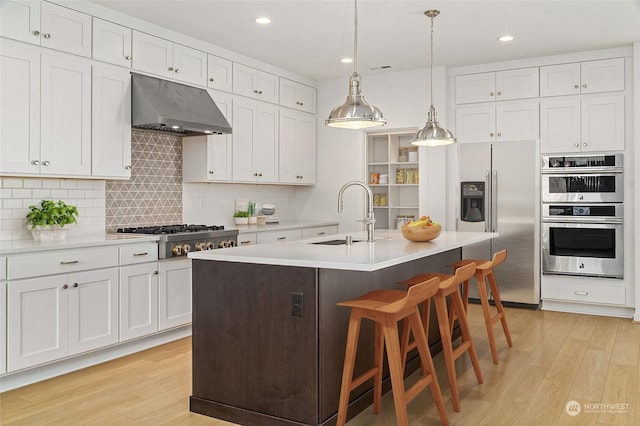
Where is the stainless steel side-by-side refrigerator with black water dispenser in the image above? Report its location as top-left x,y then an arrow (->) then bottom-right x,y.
456,140 -> 540,307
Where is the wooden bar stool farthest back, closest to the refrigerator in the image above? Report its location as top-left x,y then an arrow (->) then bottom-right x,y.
451,249 -> 513,365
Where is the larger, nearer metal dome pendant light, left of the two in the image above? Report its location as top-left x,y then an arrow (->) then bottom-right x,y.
324,0 -> 387,129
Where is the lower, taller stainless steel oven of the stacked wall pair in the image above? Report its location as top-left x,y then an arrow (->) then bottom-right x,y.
542,203 -> 624,278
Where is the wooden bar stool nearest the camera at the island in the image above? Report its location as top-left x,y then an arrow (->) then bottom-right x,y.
338,278 -> 449,426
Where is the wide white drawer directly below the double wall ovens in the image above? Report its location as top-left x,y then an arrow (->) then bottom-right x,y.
542,280 -> 626,305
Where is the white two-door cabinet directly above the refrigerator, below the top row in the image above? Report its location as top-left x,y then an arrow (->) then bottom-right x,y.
456,100 -> 539,142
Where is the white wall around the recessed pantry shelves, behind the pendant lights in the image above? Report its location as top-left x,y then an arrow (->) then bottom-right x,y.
296,69 -> 448,232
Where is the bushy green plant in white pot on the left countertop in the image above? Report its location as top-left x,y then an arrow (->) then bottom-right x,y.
26,200 -> 78,241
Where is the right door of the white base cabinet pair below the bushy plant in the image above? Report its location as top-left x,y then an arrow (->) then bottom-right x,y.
68,268 -> 118,355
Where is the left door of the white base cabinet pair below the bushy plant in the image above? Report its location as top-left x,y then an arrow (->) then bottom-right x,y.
7,274 -> 69,372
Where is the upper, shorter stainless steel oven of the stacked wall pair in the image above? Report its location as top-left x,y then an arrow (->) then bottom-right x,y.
542,154 -> 624,203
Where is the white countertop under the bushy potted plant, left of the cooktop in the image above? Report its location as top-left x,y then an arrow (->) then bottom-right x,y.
0,233 -> 158,255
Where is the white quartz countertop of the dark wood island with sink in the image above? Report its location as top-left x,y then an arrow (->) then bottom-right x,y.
189,229 -> 498,271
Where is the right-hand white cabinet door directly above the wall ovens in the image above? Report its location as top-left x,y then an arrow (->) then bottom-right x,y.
581,95 -> 625,151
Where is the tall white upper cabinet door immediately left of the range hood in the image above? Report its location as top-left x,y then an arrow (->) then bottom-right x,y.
91,65 -> 131,179
